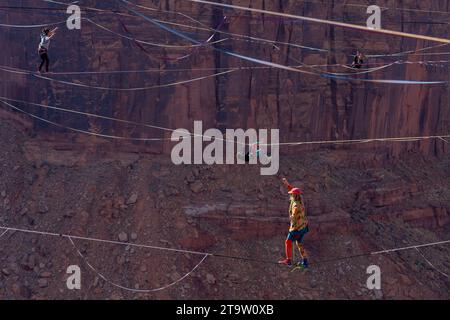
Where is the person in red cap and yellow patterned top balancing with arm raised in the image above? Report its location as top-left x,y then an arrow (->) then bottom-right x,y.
278,178 -> 309,268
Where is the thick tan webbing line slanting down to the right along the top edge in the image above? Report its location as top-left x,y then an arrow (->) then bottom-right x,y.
181,0 -> 450,44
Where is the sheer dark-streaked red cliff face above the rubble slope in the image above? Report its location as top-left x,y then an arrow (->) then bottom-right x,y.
0,0 -> 450,157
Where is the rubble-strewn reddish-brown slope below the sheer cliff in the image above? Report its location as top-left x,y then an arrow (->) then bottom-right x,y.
0,122 -> 450,299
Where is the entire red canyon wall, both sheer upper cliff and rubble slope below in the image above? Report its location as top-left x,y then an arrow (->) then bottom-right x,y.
0,1 -> 450,299
